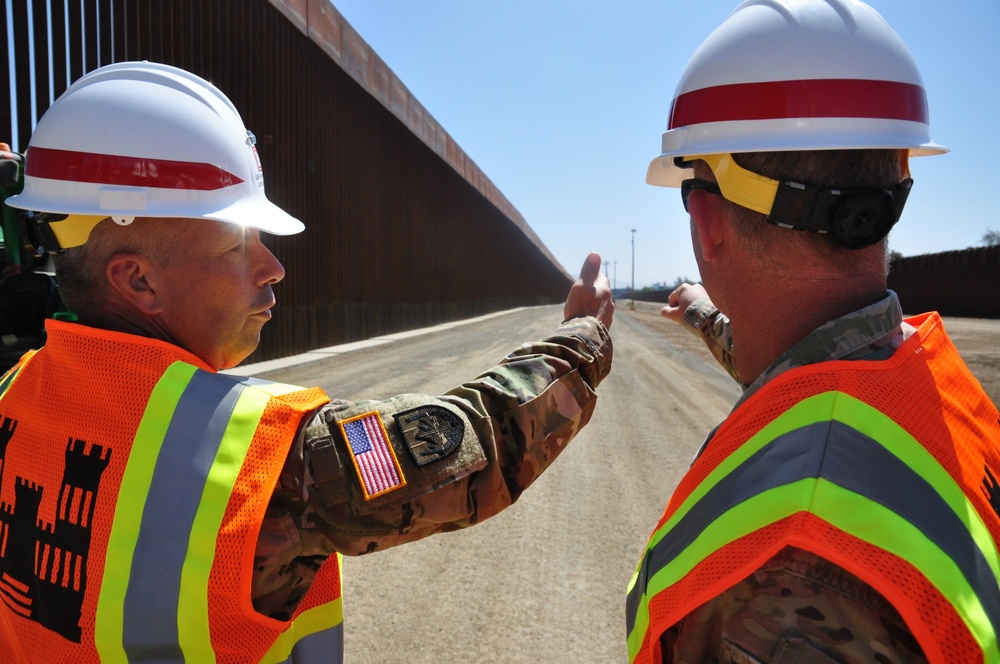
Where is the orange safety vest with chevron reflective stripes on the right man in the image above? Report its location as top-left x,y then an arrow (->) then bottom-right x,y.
626,314 -> 1000,663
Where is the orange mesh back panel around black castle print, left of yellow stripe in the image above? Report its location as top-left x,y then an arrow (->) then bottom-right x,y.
0,321 -> 200,662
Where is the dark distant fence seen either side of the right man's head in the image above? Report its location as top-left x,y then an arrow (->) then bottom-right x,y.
619,246 -> 1000,318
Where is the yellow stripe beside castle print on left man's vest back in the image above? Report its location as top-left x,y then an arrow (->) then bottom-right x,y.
94,362 -> 196,662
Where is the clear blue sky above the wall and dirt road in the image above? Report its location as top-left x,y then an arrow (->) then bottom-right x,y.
334,0 -> 1000,287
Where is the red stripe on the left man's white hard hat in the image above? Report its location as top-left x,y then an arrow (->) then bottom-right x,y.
24,146 -> 243,191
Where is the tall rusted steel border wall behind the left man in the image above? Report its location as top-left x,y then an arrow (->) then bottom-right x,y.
0,0 -> 571,361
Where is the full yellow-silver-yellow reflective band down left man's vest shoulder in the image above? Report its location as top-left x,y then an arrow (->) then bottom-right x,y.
95,362 -> 283,662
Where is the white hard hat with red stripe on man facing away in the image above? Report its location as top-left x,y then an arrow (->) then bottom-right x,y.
646,0 -> 947,187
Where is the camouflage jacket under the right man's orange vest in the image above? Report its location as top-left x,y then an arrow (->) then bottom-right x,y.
662,291 -> 926,664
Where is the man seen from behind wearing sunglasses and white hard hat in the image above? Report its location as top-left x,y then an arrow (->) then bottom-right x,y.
626,0 -> 1000,663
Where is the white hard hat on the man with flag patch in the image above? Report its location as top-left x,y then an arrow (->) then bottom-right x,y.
7,62 -> 304,248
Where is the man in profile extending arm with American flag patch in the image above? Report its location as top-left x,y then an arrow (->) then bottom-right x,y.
0,62 -> 614,664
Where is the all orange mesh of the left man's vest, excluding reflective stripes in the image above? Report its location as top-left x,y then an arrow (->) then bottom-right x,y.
0,321 -> 340,664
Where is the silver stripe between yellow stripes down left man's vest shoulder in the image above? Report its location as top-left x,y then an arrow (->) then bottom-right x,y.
122,371 -> 244,662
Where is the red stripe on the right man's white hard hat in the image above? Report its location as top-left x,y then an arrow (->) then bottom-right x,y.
668,79 -> 928,129
